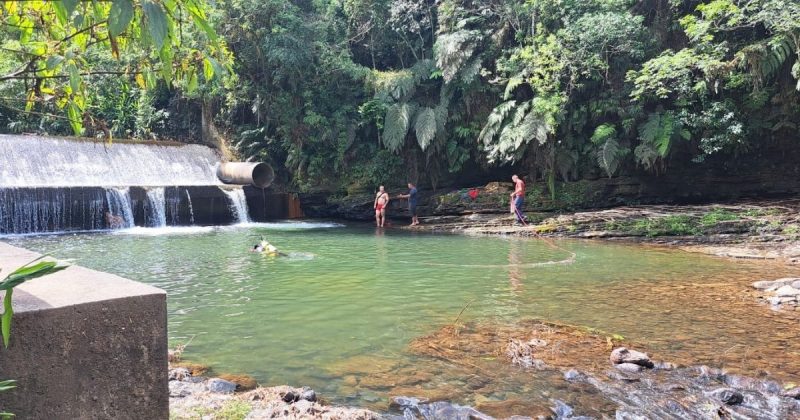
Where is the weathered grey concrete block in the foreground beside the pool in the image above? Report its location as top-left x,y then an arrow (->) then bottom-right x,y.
0,243 -> 169,419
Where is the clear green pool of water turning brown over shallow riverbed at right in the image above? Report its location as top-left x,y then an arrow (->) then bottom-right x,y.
4,223 -> 800,414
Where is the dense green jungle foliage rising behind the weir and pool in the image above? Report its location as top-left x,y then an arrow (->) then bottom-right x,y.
0,0 -> 800,191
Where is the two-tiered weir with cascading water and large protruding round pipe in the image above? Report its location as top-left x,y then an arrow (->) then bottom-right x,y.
0,135 -> 296,235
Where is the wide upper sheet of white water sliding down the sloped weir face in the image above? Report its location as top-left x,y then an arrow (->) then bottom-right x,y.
0,135 -> 221,188
